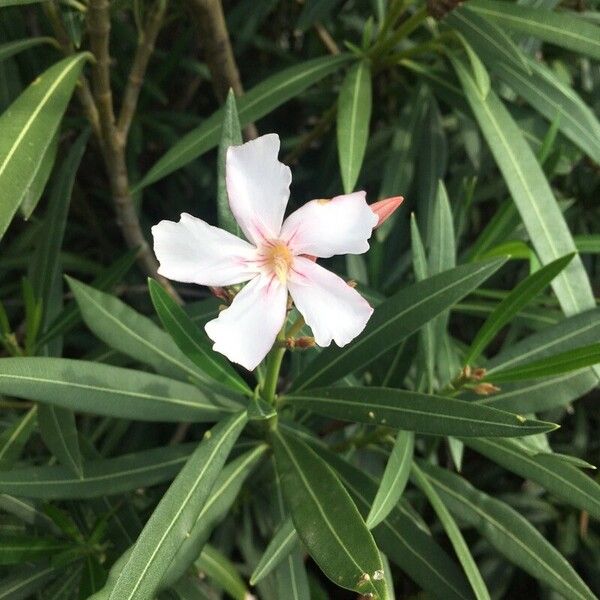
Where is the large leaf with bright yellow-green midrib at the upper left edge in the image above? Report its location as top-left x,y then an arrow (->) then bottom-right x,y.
0,54 -> 89,238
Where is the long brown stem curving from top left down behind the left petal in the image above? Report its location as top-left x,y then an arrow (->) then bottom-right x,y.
88,0 -> 180,300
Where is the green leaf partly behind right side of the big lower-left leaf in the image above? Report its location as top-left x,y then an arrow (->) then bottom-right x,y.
161,444 -> 268,587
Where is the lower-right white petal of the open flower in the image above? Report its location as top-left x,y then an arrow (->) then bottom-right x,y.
288,256 -> 373,346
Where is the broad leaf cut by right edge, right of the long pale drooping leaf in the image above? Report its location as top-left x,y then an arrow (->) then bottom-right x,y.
494,57 -> 600,162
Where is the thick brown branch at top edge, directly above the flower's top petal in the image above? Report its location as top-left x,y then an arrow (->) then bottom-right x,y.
188,0 -> 258,139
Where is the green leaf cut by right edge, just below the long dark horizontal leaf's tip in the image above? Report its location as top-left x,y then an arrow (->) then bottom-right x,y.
465,438 -> 600,520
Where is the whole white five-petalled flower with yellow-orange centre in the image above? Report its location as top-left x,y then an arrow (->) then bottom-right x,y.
152,134 -> 378,369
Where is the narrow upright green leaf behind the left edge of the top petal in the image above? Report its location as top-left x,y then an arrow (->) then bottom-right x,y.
217,89 -> 243,238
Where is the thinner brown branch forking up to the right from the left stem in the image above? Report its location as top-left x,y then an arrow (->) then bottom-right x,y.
117,0 -> 167,139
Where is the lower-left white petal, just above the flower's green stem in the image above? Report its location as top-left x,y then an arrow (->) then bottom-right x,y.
204,275 -> 287,371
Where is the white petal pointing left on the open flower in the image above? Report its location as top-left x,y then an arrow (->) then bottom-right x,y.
152,213 -> 257,286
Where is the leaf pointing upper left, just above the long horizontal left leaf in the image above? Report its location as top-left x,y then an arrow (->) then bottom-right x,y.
67,277 -> 205,381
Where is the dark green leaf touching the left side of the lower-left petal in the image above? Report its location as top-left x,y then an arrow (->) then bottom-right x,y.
148,279 -> 252,394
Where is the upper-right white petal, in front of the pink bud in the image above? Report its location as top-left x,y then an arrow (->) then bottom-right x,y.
281,192 -> 378,258
